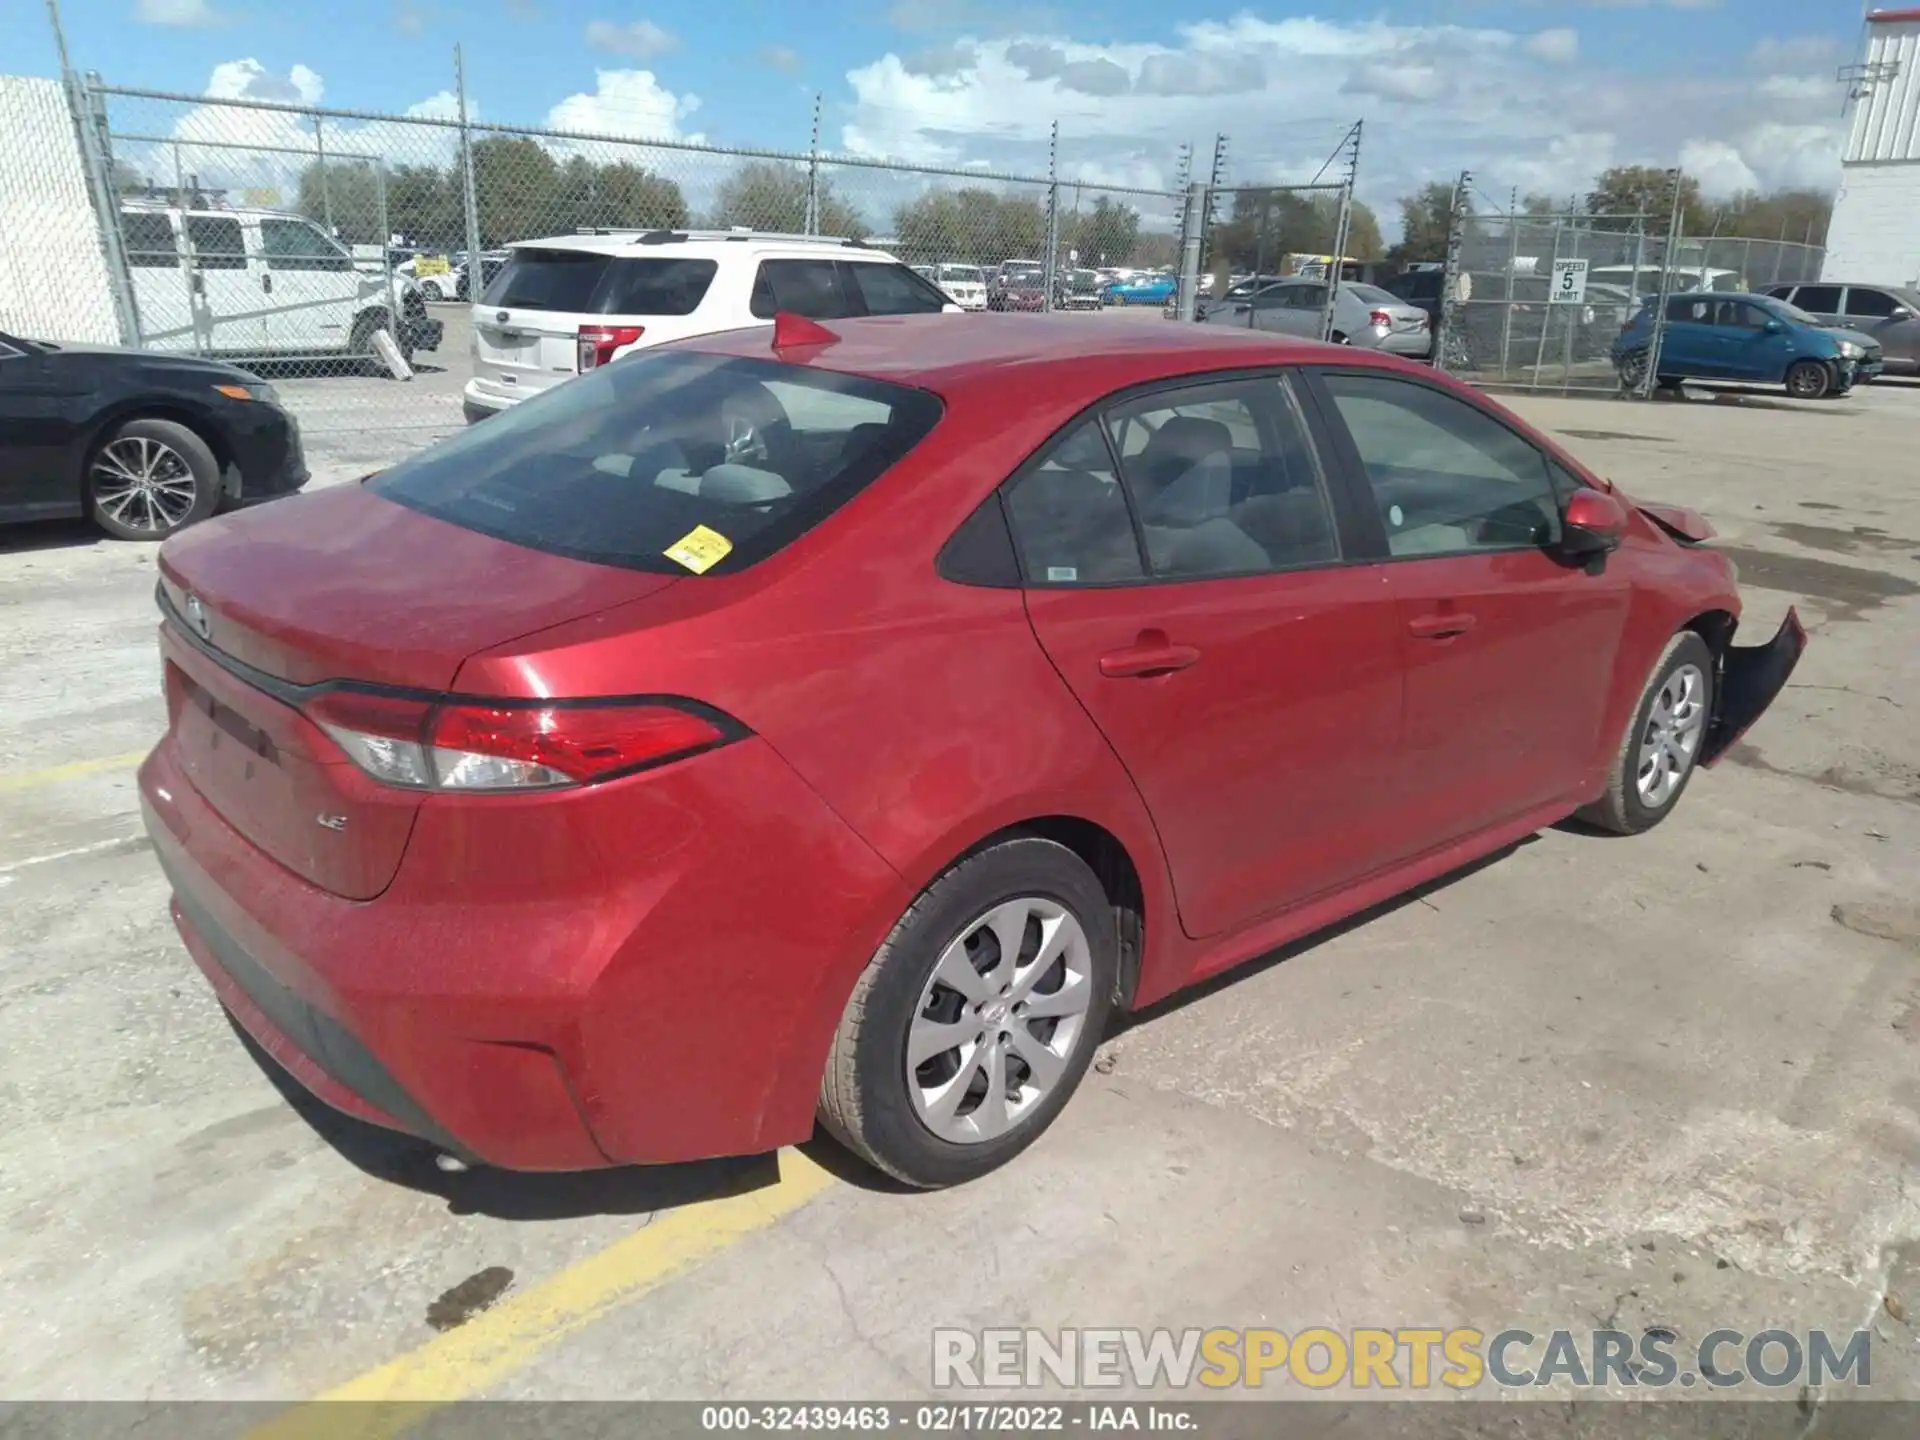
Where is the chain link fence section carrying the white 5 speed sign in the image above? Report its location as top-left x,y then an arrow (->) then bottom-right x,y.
1428,213 -> 1824,392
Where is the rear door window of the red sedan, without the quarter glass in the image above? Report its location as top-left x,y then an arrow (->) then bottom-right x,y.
1108,378 -> 1340,578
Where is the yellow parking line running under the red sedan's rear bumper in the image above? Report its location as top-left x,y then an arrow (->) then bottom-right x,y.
248,1150 -> 833,1440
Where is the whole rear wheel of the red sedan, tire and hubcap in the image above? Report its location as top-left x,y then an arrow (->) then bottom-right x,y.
820,837 -> 1119,1188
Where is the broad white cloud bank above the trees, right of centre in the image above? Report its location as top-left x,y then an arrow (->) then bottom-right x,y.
839,12 -> 1841,234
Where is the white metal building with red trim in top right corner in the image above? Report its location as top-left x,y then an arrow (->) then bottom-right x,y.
1822,10 -> 1920,284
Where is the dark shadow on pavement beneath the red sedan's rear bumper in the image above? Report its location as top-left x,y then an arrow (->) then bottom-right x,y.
227,1016 -> 783,1221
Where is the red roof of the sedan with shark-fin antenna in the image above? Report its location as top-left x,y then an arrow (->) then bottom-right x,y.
676,315 -> 1428,411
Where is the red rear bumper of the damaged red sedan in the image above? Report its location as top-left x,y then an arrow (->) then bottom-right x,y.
140,735 -> 906,1171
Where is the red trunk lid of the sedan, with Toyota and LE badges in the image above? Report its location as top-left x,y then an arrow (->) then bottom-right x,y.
159,486 -> 674,900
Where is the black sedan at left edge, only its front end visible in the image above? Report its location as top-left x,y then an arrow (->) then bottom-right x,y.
0,334 -> 307,540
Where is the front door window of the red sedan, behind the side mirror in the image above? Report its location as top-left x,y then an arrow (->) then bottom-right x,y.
1325,374 -> 1559,557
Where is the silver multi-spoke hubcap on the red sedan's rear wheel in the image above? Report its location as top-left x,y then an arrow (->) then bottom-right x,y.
906,897 -> 1092,1144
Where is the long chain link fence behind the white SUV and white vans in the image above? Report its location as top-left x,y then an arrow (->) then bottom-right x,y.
0,77 -> 1187,456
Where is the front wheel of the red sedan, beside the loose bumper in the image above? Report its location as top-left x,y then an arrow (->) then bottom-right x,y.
1578,630 -> 1716,835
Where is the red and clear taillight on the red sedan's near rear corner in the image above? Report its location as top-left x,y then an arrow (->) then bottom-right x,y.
303,689 -> 733,791
